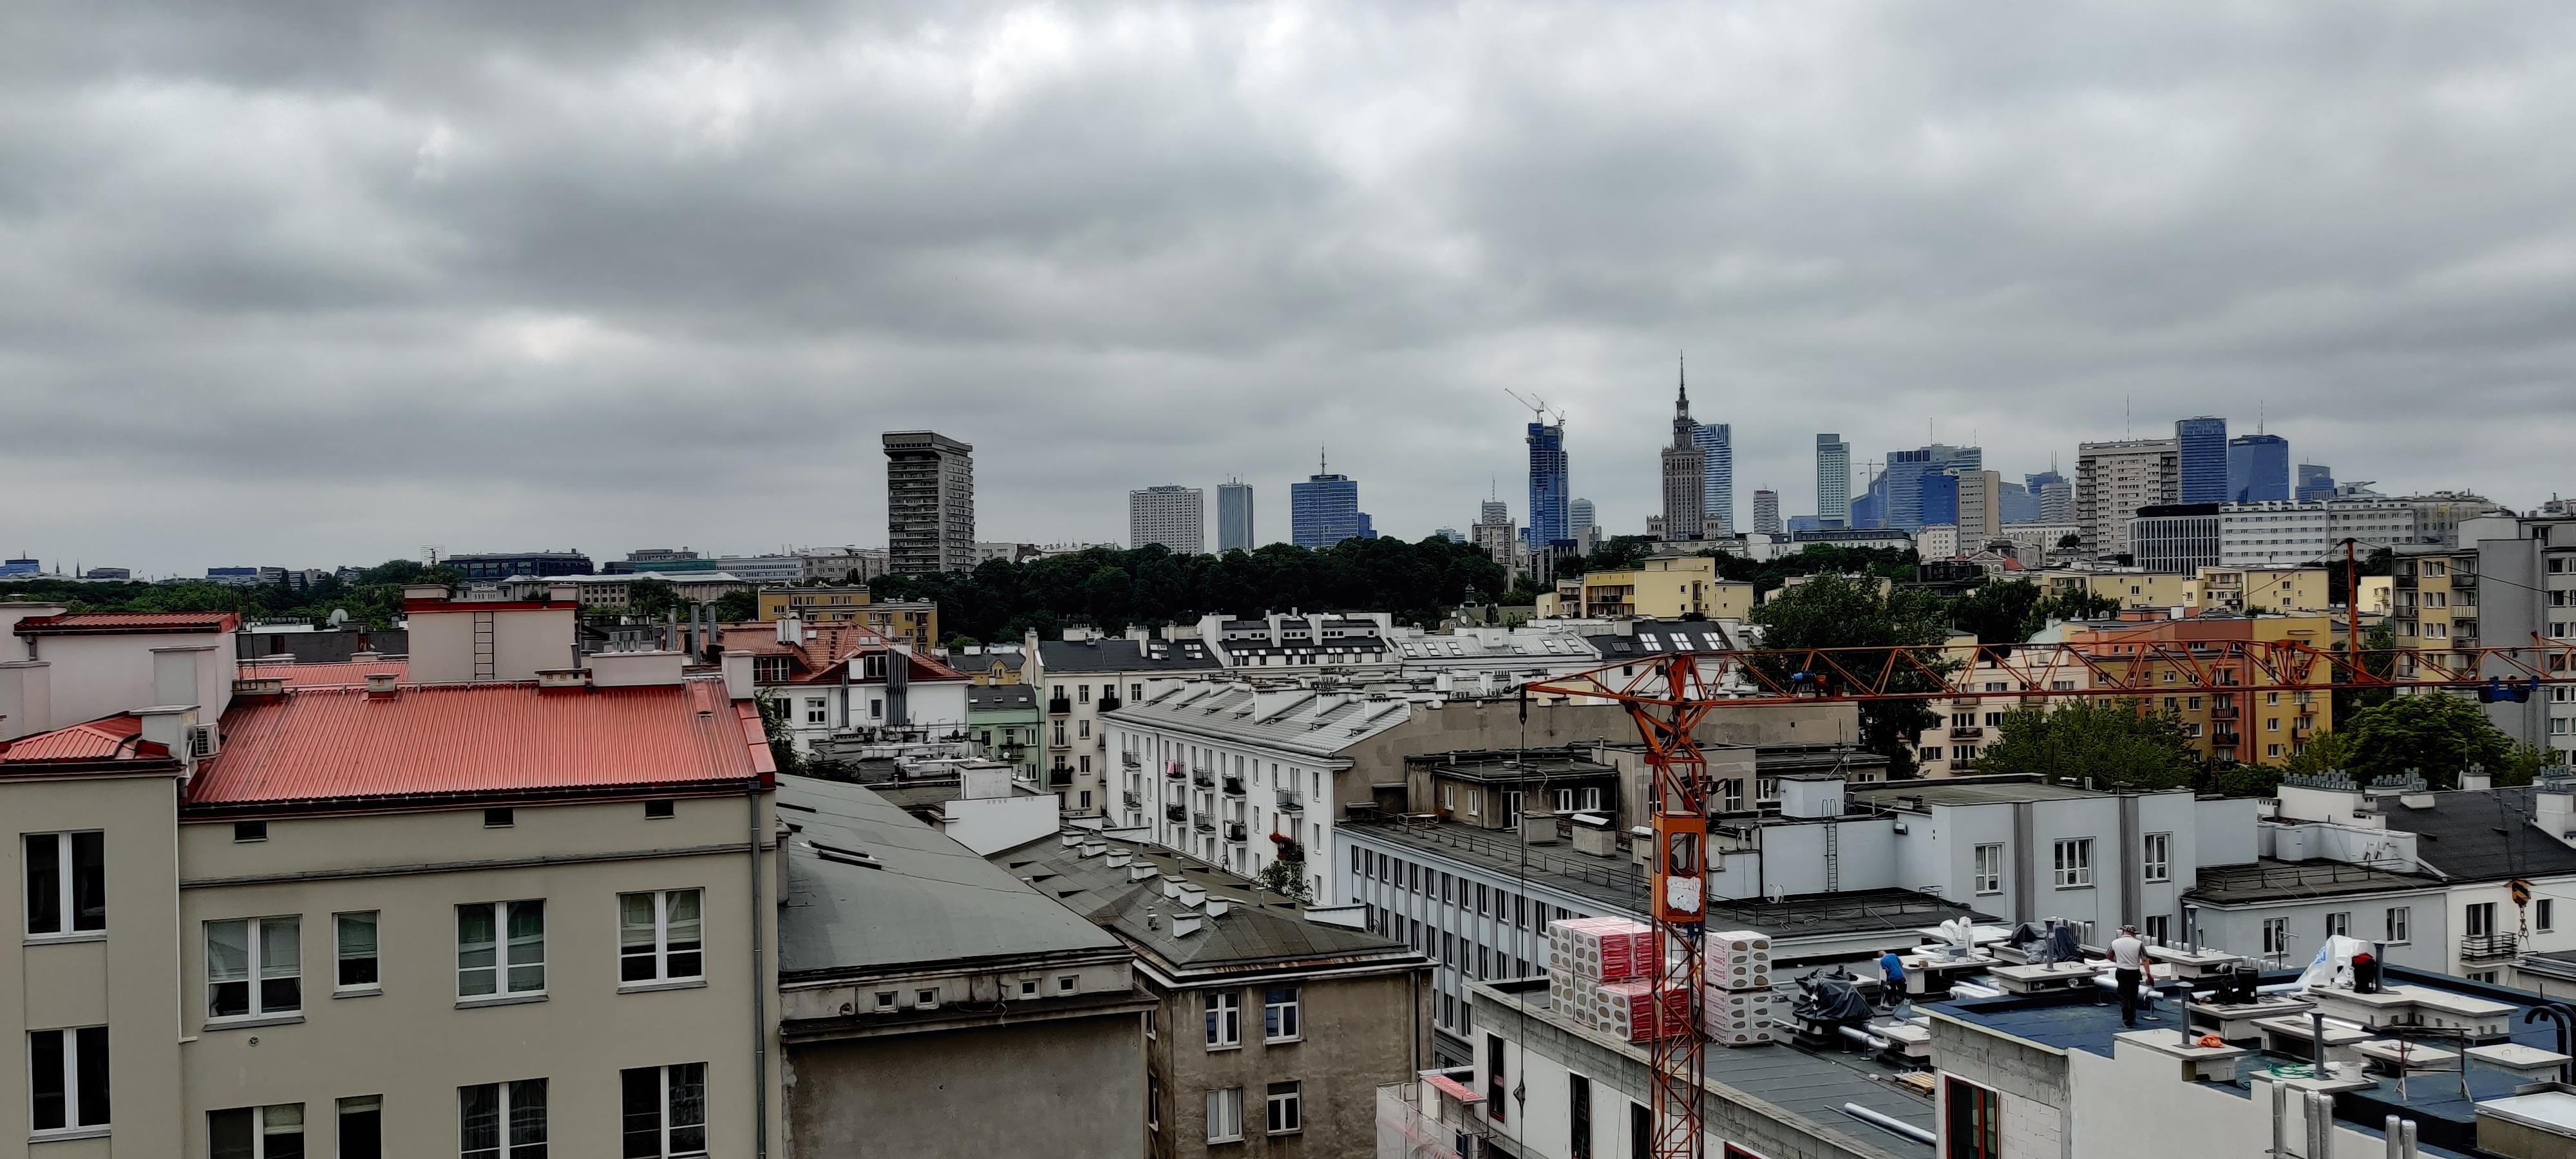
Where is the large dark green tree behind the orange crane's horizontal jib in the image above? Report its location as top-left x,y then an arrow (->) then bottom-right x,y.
1752,574 -> 1950,778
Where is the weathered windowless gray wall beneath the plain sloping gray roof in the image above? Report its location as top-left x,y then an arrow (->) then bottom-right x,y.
786,1015 -> 1144,1159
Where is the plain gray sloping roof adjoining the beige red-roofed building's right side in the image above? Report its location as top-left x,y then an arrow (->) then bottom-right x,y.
778,775 -> 1118,976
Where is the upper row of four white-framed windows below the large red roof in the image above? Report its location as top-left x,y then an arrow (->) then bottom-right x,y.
206,889 -> 706,1020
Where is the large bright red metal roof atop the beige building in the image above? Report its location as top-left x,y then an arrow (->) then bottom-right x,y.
188,680 -> 775,811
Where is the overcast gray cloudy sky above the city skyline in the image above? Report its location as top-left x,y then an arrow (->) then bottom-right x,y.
0,0 -> 2576,574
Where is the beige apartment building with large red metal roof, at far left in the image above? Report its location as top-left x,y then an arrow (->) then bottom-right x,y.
0,590 -> 783,1159
